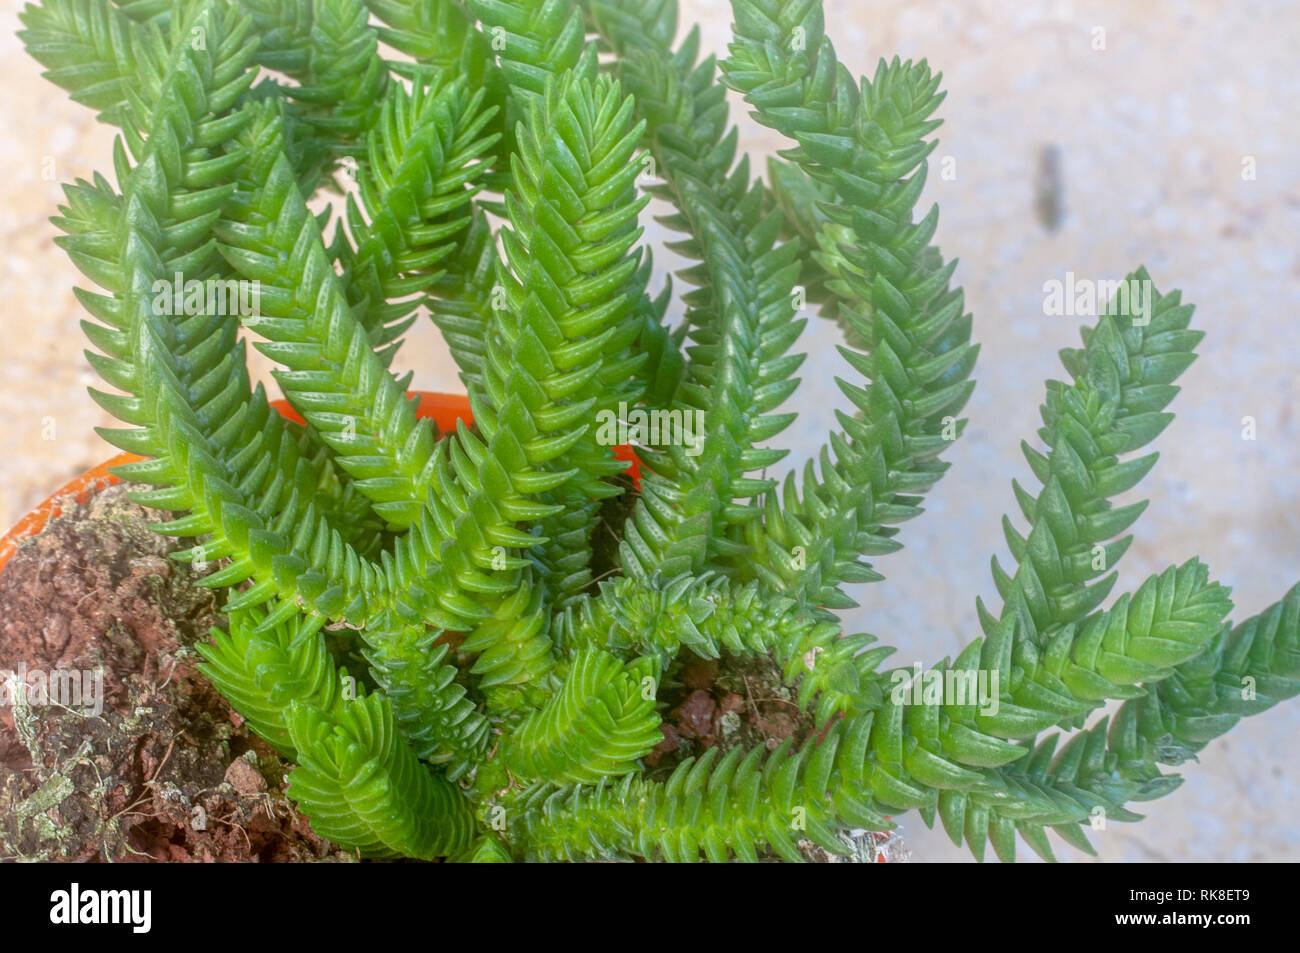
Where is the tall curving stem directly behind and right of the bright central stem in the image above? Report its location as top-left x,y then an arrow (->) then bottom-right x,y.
589,1 -> 805,576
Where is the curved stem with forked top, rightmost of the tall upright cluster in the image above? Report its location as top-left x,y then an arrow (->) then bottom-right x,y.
723,0 -> 978,607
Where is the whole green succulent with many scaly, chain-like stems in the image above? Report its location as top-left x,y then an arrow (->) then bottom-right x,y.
22,0 -> 1300,861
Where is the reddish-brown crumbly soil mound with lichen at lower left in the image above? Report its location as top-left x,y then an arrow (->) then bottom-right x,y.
0,486 -> 354,862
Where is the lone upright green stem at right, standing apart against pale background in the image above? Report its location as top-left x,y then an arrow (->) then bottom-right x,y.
980,269 -> 1204,650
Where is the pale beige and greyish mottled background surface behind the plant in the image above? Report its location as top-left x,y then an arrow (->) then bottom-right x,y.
0,0 -> 1300,862
